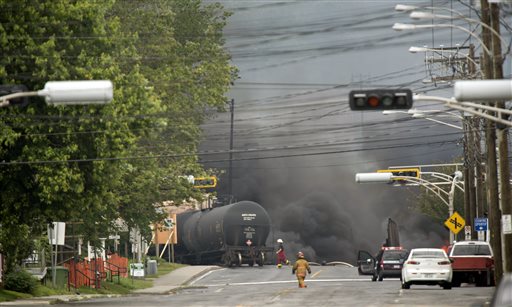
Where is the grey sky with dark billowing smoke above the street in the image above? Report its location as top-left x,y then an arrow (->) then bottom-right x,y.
200,0 -> 510,263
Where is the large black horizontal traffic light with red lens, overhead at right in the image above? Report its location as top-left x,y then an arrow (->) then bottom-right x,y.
349,89 -> 412,111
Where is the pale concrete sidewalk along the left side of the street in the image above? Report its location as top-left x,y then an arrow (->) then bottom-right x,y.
0,265 -> 220,306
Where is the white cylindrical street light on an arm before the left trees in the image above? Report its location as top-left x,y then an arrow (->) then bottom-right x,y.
0,80 -> 114,108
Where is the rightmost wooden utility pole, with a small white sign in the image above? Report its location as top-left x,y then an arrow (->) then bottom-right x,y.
490,3 -> 512,272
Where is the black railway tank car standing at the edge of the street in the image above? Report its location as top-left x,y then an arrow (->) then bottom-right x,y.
175,201 -> 273,266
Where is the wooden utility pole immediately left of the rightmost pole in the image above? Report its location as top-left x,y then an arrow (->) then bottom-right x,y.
480,0 -> 508,284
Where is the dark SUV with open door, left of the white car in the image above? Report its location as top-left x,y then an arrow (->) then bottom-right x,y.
357,247 -> 409,281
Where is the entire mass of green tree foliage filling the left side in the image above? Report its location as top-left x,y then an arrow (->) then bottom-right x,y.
0,0 -> 236,274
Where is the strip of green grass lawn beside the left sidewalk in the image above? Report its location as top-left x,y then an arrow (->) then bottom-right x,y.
0,262 -> 185,302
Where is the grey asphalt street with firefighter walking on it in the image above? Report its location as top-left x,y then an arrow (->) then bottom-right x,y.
58,265 -> 495,307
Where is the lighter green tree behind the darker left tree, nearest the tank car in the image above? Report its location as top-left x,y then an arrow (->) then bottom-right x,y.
112,0 -> 236,243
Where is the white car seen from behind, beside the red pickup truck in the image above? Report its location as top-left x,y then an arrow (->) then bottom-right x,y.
402,248 -> 453,289
